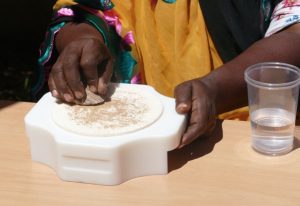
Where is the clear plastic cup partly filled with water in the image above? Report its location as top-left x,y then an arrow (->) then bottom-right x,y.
245,62 -> 300,155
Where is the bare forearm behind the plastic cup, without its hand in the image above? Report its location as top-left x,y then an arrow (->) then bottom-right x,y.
202,25 -> 300,114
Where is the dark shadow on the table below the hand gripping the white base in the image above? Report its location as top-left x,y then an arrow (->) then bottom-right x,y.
168,120 -> 223,172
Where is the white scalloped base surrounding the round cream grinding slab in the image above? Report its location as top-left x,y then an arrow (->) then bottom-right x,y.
25,84 -> 185,185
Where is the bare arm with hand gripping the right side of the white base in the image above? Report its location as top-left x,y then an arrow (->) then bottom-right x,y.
175,24 -> 300,147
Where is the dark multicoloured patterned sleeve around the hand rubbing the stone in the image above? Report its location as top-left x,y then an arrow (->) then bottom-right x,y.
32,0 -> 140,99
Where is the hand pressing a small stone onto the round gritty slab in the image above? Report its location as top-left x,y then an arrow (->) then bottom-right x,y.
48,23 -> 113,103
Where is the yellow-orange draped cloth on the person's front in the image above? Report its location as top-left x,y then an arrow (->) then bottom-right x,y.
54,0 -> 247,118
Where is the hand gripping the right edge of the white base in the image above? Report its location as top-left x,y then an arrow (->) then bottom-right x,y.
175,79 -> 216,148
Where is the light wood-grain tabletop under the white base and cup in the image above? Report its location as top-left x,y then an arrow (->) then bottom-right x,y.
0,101 -> 300,206
